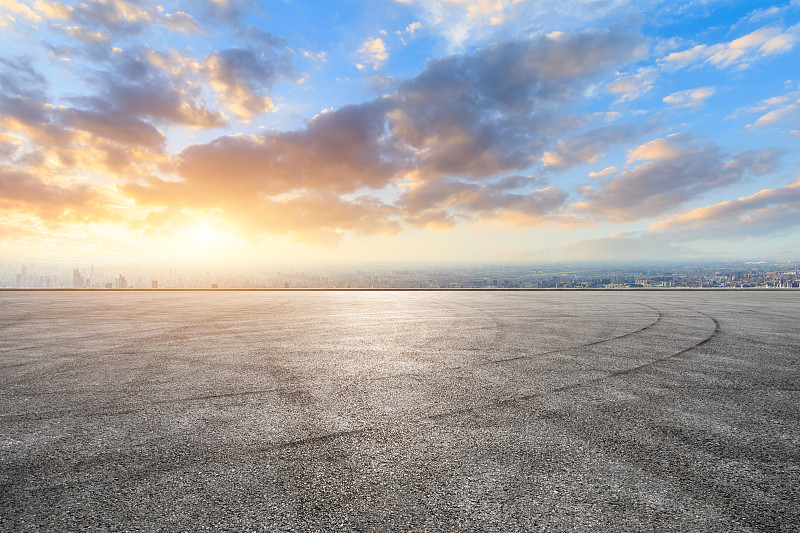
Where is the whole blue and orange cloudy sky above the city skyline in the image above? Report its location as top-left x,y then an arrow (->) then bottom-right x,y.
0,0 -> 800,265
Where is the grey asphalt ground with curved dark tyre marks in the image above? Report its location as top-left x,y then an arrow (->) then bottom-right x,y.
0,292 -> 800,533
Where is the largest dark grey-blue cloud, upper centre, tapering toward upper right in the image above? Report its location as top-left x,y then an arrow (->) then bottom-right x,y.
389,30 -> 644,178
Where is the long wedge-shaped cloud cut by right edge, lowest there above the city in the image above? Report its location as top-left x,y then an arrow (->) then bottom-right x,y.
648,179 -> 800,240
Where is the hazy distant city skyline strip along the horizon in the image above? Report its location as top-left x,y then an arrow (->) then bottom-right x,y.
0,261 -> 800,289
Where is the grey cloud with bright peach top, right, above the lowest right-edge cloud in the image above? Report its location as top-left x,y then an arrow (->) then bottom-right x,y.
574,134 -> 780,222
